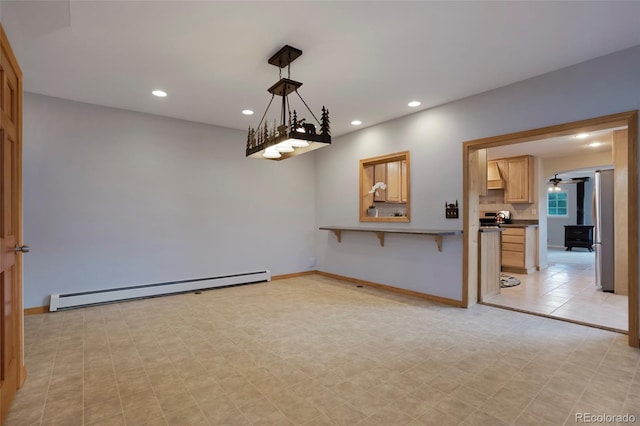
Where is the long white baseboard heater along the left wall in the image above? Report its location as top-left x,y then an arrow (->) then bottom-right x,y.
49,270 -> 271,312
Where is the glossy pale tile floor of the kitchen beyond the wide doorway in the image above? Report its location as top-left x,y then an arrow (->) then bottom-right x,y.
486,248 -> 629,332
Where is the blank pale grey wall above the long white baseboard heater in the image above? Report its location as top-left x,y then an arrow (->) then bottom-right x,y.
24,94 -> 316,308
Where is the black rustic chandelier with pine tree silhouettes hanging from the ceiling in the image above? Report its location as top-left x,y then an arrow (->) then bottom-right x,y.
247,45 -> 331,160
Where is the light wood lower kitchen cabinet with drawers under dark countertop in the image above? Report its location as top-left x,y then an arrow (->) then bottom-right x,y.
502,226 -> 536,274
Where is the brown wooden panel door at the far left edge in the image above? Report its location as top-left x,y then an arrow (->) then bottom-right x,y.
0,27 -> 25,421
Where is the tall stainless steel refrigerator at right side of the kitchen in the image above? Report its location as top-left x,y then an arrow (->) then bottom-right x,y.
593,169 -> 615,292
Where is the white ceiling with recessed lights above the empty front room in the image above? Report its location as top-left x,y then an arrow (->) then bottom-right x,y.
0,0 -> 640,136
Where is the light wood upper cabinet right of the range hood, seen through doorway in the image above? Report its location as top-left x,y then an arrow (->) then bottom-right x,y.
502,155 -> 535,204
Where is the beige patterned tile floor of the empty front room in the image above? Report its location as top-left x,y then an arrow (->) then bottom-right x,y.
6,275 -> 640,426
